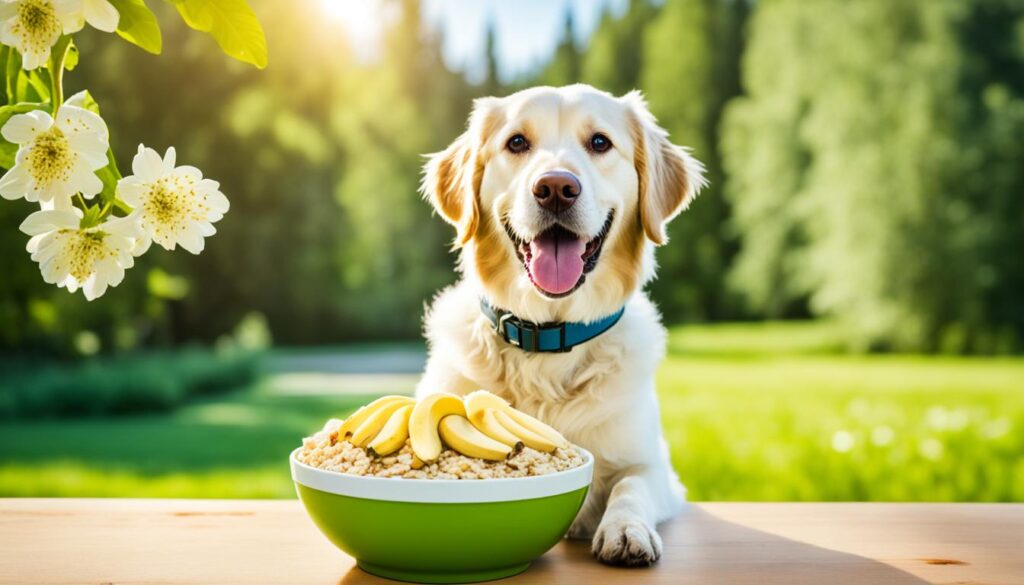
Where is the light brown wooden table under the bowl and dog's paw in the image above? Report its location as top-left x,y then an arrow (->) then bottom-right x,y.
0,499 -> 1024,585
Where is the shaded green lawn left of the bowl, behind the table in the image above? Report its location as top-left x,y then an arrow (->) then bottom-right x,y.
0,387 -> 372,498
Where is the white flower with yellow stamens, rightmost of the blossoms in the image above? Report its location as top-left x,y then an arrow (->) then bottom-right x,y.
118,144 -> 228,255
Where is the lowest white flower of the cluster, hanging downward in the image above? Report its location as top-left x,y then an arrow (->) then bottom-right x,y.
20,208 -> 140,300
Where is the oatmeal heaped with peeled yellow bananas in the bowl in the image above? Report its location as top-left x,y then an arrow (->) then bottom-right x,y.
298,390 -> 584,479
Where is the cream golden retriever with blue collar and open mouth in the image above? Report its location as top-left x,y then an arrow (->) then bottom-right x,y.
416,85 -> 706,566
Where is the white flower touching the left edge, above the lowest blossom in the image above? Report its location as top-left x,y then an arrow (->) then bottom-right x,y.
0,90 -> 109,209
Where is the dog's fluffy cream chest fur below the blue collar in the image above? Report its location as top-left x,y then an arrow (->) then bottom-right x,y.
426,284 -> 665,440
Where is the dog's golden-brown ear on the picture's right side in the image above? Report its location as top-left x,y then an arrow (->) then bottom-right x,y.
623,91 -> 708,246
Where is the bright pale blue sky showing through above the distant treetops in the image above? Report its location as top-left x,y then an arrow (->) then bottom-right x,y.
316,0 -> 627,81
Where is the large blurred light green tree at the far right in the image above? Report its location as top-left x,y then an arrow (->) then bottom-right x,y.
725,0 -> 1024,351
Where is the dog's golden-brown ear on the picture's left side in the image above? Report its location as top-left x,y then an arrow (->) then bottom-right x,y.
420,98 -> 493,247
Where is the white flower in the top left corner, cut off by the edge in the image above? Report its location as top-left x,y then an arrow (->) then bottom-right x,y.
0,0 -> 80,71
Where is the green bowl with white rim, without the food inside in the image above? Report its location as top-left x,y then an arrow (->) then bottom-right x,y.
290,449 -> 594,583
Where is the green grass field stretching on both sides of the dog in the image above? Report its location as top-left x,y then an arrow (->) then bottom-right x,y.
0,323 -> 1024,501
